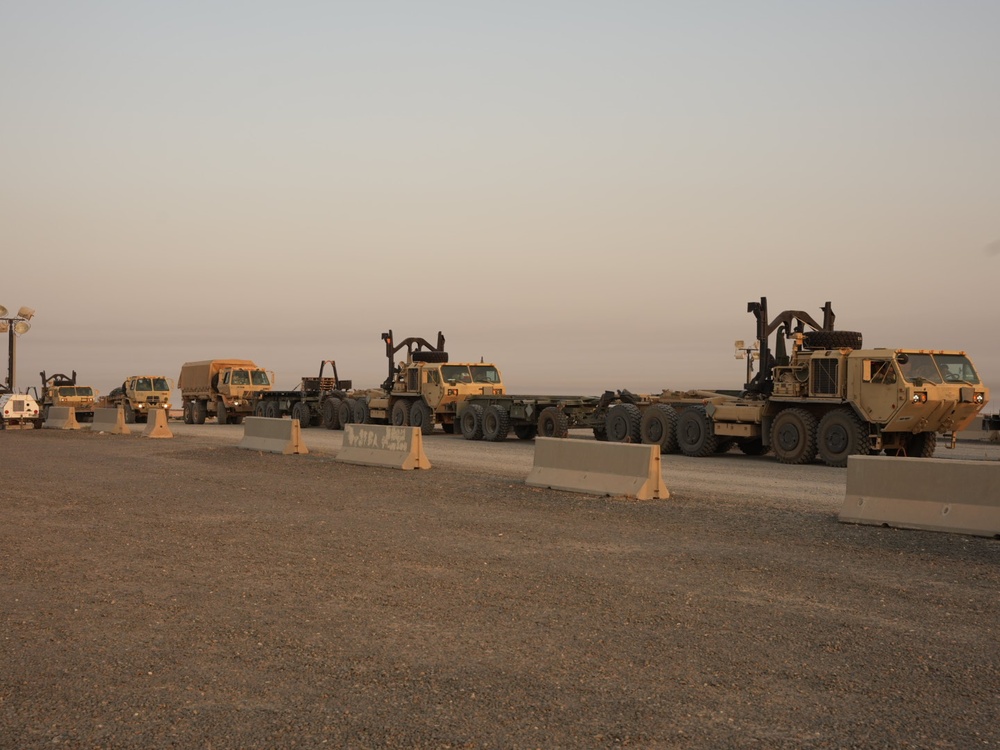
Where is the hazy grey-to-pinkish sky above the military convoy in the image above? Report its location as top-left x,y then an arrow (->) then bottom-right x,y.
0,0 -> 1000,403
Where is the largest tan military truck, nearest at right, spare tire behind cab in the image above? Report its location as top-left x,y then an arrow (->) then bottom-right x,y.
604,298 -> 989,466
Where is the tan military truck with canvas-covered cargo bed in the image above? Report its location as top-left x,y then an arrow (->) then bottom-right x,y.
177,359 -> 274,424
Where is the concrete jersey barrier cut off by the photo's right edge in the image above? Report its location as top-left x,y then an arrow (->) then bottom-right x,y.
840,456 -> 1000,536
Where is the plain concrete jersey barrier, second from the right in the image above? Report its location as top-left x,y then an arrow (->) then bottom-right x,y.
525,438 -> 670,500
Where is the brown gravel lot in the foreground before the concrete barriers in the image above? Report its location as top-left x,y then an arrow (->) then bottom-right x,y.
0,431 -> 1000,749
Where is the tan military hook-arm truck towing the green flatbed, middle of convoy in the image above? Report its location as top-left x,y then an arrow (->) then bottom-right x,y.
336,331 -> 504,435
